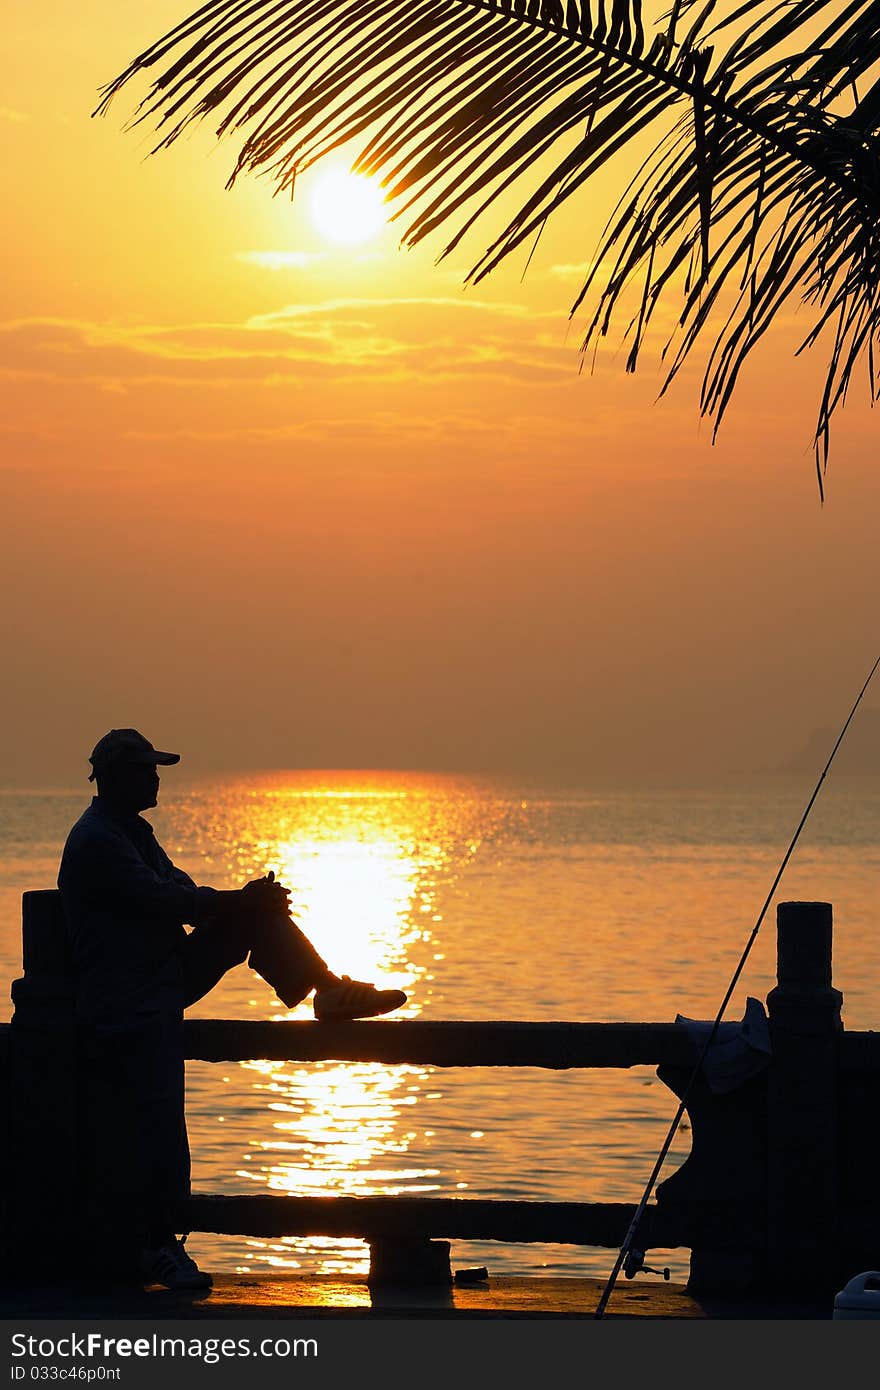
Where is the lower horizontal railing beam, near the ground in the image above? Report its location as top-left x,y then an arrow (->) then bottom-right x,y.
175,1193 -> 685,1250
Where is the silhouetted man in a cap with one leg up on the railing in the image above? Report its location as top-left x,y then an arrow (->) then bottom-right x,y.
58,728 -> 406,1289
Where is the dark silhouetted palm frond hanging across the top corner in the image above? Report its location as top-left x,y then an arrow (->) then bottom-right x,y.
97,0 -> 880,489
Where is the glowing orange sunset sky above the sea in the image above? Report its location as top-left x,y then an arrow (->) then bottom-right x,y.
0,0 -> 880,785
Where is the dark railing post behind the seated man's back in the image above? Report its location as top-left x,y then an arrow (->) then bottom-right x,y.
3,890 -> 78,1275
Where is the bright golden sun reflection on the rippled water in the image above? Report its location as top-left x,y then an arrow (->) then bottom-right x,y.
204,783 -> 445,1273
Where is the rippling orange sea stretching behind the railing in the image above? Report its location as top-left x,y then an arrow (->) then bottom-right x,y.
0,769 -> 880,1280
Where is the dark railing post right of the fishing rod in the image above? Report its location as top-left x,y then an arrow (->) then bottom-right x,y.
767,902 -> 842,1297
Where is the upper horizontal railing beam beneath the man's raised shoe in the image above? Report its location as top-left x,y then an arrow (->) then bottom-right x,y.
184,1019 -> 696,1069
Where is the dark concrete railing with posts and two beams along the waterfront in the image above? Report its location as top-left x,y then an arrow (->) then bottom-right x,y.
0,891 -> 880,1295
